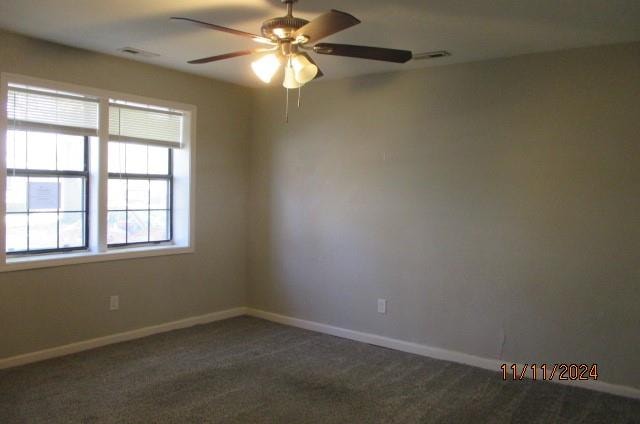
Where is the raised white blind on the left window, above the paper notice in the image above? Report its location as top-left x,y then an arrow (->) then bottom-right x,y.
7,85 -> 98,136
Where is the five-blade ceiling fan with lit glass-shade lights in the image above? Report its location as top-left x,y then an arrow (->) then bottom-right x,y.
171,0 -> 413,89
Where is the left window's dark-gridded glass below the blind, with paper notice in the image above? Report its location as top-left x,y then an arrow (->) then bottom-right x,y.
6,130 -> 89,254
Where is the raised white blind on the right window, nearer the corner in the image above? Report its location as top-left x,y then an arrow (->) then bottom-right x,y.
109,101 -> 183,148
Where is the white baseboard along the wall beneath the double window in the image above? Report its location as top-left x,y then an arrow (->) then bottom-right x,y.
0,307 -> 247,369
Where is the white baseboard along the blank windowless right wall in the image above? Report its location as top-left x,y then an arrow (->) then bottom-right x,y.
247,308 -> 640,399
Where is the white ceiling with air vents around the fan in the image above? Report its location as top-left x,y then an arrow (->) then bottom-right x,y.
0,0 -> 640,86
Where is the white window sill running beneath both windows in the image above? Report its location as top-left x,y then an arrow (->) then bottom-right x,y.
0,245 -> 194,272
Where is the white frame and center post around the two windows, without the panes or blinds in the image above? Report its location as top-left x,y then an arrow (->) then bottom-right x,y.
0,72 -> 197,272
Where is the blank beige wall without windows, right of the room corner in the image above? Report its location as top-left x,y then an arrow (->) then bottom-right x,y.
249,44 -> 640,387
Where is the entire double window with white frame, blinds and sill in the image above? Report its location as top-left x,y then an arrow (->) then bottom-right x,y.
0,74 -> 195,271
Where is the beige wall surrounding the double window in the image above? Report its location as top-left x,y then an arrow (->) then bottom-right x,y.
0,32 -> 252,358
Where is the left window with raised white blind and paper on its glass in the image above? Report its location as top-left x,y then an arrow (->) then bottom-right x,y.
5,84 -> 98,255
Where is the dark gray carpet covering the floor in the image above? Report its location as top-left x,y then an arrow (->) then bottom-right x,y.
0,317 -> 640,424
